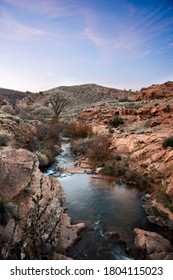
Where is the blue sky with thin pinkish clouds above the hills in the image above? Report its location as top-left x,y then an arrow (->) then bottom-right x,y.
0,0 -> 173,92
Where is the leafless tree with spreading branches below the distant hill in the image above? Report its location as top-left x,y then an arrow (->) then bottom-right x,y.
48,92 -> 69,116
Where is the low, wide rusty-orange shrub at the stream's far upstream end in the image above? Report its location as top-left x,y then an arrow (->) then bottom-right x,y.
65,122 -> 92,139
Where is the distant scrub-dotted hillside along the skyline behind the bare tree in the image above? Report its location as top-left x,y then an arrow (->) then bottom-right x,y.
0,84 -> 136,115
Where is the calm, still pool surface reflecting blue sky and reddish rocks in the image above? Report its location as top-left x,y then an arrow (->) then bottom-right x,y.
60,174 -> 146,241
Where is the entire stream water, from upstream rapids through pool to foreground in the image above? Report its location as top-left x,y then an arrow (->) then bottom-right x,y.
46,143 -> 164,259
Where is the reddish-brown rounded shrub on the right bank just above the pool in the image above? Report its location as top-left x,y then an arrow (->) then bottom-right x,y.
88,135 -> 111,161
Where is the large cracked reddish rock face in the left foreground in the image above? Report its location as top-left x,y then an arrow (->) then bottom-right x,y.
0,148 -> 64,259
